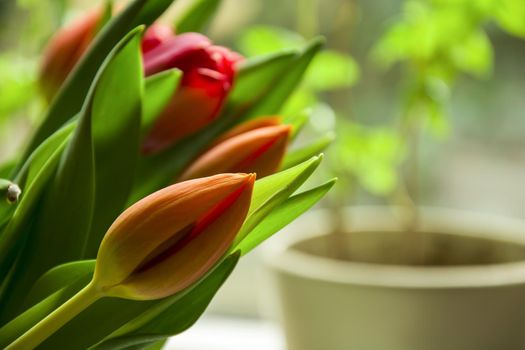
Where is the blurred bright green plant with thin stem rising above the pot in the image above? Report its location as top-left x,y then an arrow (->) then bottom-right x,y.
372,0 -> 525,230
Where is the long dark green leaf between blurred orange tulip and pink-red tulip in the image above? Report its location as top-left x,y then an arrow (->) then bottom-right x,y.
23,0 -> 173,160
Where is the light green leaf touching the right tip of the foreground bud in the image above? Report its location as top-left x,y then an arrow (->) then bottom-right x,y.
231,155 -> 323,245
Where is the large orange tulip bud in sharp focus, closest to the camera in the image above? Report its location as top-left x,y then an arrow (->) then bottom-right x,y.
93,174 -> 255,300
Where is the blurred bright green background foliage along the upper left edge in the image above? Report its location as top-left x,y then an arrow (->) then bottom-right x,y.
0,0 -> 66,159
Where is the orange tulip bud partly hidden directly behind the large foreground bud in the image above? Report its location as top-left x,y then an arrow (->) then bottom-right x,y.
179,125 -> 291,180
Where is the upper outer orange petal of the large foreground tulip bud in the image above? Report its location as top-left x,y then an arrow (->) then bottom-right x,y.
95,174 -> 253,286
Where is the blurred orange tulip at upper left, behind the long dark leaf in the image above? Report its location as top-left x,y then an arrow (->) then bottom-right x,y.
39,8 -> 104,101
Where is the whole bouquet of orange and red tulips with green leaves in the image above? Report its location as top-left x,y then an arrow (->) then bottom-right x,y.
0,0 -> 334,349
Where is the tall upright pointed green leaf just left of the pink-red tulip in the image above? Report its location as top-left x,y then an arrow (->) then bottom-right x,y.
85,28 -> 144,258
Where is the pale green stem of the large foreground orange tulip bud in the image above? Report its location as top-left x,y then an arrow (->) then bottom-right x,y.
6,282 -> 103,350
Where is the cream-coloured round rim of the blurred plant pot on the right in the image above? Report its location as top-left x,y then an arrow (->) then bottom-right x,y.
264,206 -> 525,289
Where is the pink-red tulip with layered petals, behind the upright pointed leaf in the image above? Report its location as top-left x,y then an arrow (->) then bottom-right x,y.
142,33 -> 241,154
